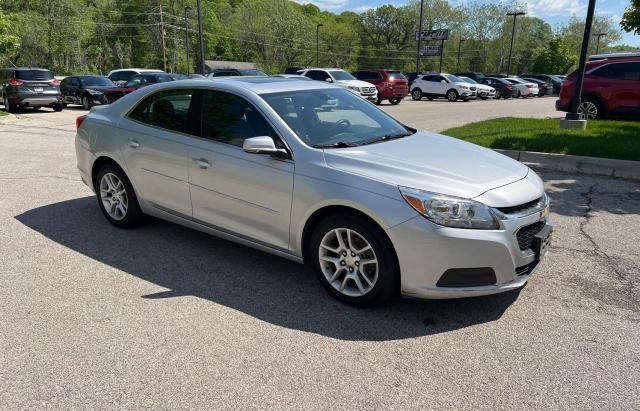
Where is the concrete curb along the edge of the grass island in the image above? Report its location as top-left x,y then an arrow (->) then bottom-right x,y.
494,149 -> 640,180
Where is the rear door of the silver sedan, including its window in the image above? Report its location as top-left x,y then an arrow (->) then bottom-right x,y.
119,89 -> 197,218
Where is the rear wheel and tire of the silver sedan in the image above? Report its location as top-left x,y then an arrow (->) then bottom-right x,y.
94,164 -> 143,228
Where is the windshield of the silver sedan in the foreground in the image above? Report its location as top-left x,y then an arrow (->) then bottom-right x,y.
262,89 -> 412,147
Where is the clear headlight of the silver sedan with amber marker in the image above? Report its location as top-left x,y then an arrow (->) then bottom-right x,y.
399,187 -> 500,230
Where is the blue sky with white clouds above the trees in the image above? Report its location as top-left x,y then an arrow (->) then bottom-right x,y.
295,0 -> 640,47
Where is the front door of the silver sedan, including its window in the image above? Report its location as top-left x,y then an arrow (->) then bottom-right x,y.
189,90 -> 294,251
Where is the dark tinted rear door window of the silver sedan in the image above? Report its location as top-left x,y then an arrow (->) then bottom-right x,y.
129,90 -> 196,134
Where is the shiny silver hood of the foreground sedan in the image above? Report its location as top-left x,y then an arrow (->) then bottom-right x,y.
324,132 -> 529,198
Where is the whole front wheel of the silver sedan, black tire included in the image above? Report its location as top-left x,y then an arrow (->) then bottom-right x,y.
308,214 -> 399,306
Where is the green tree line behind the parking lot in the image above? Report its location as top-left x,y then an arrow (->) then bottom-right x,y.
0,0 -> 626,74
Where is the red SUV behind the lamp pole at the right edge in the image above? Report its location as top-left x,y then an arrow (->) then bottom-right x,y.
556,57 -> 640,119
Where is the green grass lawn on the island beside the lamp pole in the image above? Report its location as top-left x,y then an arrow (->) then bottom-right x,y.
442,117 -> 640,161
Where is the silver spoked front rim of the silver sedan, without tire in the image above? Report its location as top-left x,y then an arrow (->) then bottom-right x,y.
318,228 -> 379,297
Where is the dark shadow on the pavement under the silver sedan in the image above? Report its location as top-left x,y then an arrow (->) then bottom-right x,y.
16,197 -> 519,341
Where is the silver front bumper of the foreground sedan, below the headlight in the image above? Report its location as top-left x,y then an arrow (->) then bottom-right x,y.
387,212 -> 551,299
